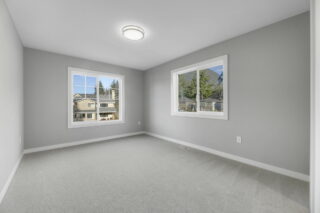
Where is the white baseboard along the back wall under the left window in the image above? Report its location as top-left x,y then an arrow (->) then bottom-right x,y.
23,131 -> 145,154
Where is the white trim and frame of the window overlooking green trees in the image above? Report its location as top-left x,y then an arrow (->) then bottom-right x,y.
171,55 -> 229,120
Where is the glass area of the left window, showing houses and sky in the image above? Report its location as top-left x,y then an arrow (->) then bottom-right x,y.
70,70 -> 122,125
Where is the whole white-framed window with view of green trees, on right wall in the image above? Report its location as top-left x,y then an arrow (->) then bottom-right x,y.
171,55 -> 228,120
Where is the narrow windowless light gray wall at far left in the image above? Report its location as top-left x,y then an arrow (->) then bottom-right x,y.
0,0 -> 23,196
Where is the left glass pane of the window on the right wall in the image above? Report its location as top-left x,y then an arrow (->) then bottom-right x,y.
178,71 -> 197,112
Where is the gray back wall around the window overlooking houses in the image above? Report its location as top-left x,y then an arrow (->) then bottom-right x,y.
24,48 -> 144,148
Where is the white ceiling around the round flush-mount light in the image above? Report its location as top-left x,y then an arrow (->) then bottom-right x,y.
6,0 -> 309,70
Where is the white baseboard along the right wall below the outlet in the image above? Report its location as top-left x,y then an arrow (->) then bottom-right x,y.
146,132 -> 309,182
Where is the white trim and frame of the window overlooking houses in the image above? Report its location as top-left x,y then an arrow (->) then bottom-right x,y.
68,67 -> 125,128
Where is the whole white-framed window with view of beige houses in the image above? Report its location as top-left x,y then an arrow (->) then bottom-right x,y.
68,67 -> 124,128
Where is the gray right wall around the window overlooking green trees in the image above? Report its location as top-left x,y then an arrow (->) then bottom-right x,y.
145,13 -> 310,174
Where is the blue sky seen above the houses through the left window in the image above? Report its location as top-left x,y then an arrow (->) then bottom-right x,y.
73,75 -> 115,94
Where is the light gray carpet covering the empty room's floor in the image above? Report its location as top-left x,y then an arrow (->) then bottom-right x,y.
0,135 -> 308,213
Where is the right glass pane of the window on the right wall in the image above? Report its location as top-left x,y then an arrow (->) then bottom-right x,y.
199,65 -> 223,112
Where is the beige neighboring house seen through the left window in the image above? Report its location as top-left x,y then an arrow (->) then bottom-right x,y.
73,89 -> 118,121
